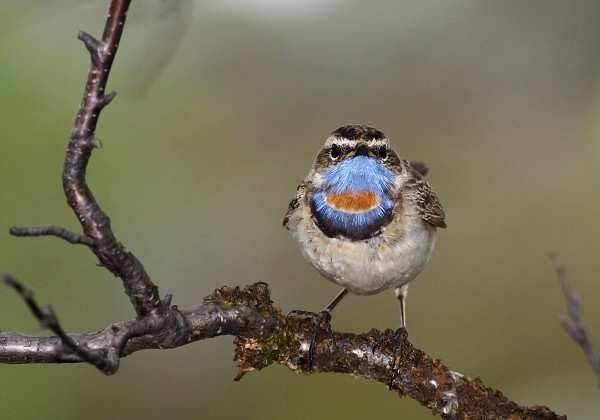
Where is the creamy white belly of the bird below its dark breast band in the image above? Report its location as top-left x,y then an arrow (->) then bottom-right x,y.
293,218 -> 436,295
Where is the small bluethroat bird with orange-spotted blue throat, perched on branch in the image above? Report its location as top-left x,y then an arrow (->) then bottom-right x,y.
283,125 -> 446,328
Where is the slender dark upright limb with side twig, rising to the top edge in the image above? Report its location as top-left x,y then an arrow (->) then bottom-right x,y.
10,0 -> 161,316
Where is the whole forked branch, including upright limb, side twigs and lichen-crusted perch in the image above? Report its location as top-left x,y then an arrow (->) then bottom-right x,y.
0,0 -> 566,419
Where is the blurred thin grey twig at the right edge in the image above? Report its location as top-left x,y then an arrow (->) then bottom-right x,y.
550,255 -> 600,386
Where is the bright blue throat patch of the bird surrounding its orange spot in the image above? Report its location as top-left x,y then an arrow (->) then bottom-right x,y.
310,156 -> 395,240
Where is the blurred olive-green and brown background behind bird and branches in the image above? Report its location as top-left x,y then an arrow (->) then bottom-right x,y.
0,0 -> 600,420
